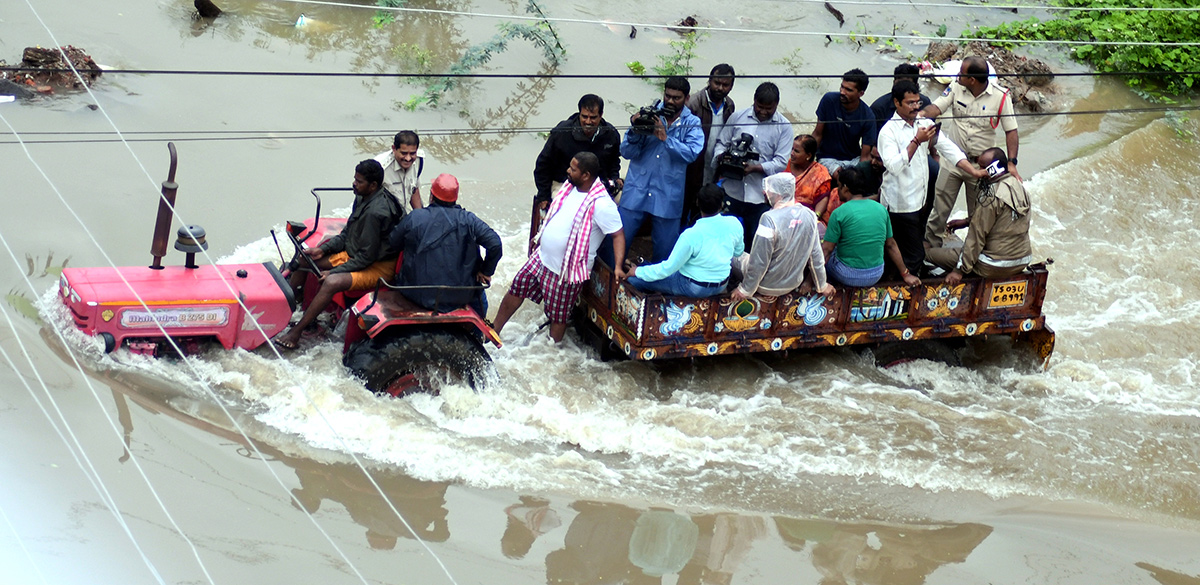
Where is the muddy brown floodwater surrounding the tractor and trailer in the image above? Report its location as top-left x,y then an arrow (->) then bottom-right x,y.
0,0 -> 1200,585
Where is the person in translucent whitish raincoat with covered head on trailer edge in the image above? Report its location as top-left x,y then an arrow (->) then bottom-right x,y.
730,171 -> 834,301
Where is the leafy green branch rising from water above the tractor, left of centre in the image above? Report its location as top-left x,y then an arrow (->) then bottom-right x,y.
398,0 -> 566,111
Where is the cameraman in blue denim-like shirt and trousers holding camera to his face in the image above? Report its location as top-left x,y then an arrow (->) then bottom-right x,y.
619,76 -> 704,263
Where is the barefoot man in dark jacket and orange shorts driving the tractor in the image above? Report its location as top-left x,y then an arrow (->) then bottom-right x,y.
275,158 -> 403,350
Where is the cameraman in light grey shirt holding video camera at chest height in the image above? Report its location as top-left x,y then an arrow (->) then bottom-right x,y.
713,82 -> 792,251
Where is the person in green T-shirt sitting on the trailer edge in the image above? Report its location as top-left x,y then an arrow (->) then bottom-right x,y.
821,167 -> 920,287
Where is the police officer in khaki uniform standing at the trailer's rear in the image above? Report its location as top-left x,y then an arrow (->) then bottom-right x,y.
922,56 -> 1021,248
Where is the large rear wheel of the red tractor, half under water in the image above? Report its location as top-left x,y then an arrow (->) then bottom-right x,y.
342,330 -> 496,397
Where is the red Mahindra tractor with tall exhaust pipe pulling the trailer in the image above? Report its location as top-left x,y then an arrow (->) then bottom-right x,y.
59,144 -> 500,396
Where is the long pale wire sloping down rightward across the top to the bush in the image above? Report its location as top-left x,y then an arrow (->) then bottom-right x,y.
267,0 -> 1200,47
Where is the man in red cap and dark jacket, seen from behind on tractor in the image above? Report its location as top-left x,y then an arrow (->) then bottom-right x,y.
388,173 -> 503,316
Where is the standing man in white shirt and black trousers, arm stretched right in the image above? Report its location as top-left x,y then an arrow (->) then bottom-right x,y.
878,80 -> 986,273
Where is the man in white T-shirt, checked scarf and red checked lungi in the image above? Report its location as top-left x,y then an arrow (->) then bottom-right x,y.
494,152 -> 625,342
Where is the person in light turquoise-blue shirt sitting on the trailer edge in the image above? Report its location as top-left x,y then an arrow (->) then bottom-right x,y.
628,183 -> 744,298
